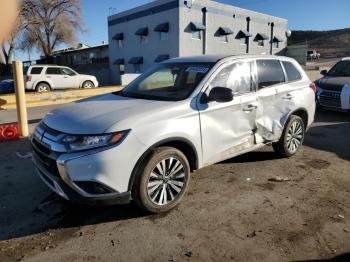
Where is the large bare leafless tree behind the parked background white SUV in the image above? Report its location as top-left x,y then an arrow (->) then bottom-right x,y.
21,0 -> 84,58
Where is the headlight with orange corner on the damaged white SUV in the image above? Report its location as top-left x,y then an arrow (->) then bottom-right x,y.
61,131 -> 129,152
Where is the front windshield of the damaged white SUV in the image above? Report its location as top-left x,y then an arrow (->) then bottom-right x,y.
117,63 -> 214,101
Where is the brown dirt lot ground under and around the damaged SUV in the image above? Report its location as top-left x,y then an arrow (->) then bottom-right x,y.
0,109 -> 350,262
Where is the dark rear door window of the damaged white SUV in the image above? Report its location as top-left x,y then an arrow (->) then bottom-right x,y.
256,60 -> 286,89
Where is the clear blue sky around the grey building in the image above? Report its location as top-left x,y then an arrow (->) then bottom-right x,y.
17,0 -> 350,60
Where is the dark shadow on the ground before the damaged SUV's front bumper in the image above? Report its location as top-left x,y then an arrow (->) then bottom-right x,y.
0,139 -> 148,241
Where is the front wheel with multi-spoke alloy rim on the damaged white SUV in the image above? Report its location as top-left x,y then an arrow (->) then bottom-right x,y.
132,147 -> 190,213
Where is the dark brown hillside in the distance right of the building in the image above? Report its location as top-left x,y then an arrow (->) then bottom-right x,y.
288,28 -> 350,57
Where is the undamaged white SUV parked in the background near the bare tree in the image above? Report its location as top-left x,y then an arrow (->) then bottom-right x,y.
26,65 -> 98,92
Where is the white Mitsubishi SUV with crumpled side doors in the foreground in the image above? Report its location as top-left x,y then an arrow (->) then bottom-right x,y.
31,56 -> 315,213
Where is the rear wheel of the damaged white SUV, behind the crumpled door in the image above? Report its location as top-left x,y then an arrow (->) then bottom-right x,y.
272,115 -> 305,157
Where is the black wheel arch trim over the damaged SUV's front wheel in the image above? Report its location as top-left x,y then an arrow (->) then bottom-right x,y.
128,137 -> 198,191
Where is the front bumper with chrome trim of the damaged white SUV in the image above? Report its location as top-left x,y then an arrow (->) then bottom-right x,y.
30,123 -> 144,204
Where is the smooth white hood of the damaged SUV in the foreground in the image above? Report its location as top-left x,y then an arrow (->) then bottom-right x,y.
43,93 -> 172,135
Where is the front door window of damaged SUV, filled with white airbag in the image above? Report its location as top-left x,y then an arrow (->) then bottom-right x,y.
210,62 -> 252,94
